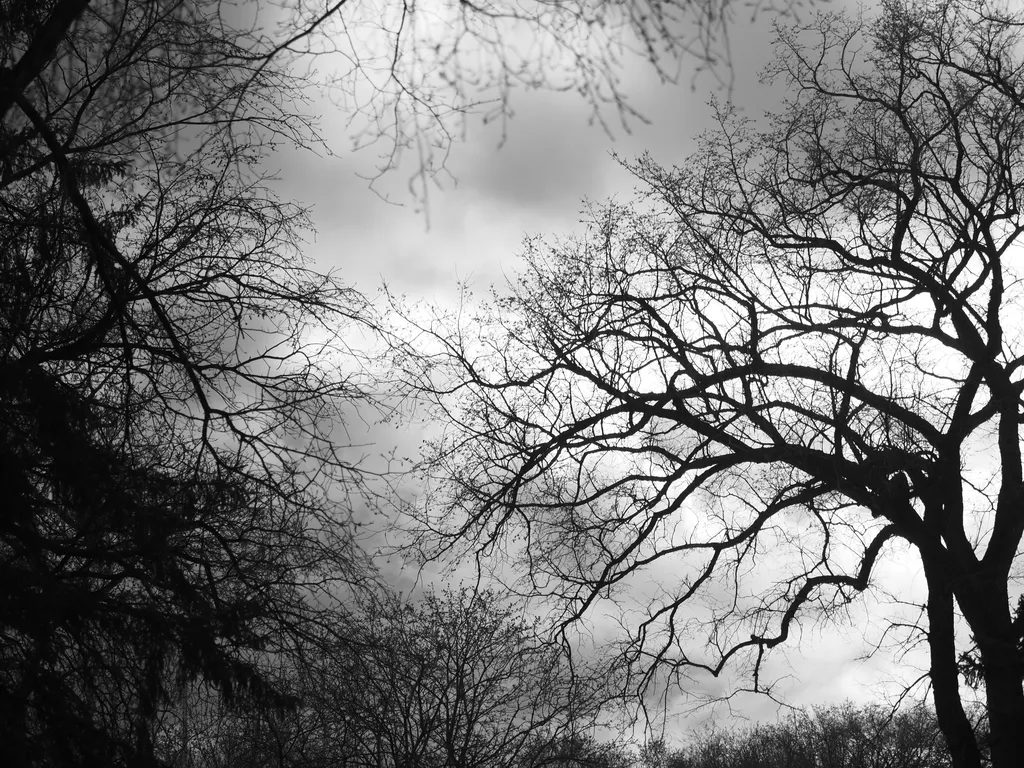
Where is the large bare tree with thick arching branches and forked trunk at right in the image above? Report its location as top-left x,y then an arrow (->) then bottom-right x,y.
395,0 -> 1024,768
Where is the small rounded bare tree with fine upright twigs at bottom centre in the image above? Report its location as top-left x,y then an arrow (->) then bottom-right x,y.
329,590 -> 606,768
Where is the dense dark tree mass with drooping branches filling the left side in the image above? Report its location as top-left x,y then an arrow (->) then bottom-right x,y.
0,1 -> 373,765
